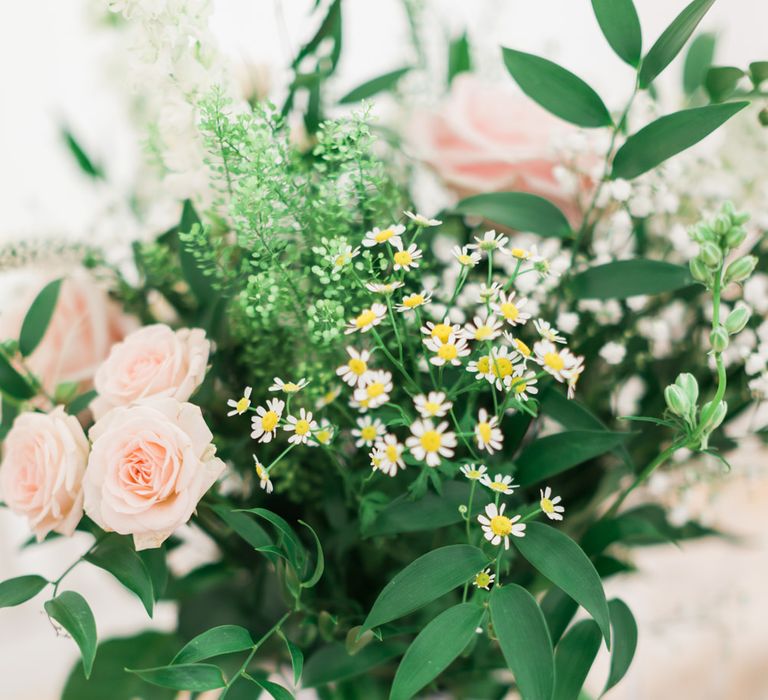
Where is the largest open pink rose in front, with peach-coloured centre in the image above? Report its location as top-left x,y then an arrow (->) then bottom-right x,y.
83,398 -> 224,550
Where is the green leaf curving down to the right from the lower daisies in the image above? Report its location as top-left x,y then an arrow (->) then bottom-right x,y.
514,522 -> 611,646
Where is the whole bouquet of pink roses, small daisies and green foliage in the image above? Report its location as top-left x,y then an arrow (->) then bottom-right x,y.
0,0 -> 765,700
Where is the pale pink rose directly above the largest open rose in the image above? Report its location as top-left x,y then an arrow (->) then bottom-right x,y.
91,323 -> 211,419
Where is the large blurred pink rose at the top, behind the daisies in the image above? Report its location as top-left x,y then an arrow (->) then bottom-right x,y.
411,73 -> 573,208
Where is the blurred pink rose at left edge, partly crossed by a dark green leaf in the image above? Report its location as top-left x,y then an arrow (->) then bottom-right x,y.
0,268 -> 136,394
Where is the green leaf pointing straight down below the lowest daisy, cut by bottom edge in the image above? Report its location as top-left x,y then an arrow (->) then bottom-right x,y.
490,583 -> 555,700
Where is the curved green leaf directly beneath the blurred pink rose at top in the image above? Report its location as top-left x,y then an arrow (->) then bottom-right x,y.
455,192 -> 573,238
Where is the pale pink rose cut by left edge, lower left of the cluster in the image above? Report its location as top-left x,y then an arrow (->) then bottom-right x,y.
0,406 -> 88,541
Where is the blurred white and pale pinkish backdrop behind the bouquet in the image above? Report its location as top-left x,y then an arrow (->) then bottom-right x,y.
0,0 -> 768,700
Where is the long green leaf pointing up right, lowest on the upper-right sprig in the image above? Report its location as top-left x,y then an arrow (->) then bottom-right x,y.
611,102 -> 749,180
